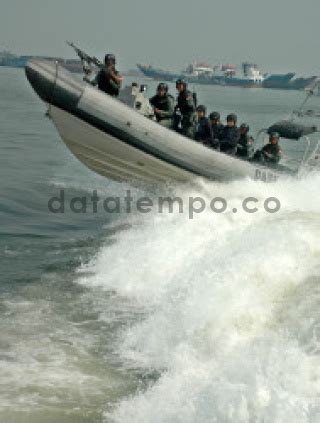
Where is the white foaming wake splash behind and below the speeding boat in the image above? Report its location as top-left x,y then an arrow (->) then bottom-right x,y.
80,176 -> 320,423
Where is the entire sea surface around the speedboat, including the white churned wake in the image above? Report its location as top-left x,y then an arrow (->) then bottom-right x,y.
0,68 -> 320,423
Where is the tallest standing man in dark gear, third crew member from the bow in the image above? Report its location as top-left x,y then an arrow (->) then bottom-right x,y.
176,79 -> 196,138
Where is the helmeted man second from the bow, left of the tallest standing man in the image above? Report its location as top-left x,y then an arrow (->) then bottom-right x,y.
150,82 -> 175,128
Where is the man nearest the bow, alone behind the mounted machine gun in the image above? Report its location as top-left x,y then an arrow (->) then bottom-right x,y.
91,54 -> 123,97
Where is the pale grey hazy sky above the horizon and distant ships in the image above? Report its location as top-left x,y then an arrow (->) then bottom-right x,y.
0,0 -> 320,74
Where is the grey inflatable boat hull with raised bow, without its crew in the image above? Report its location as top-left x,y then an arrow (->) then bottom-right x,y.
26,59 -> 320,183
